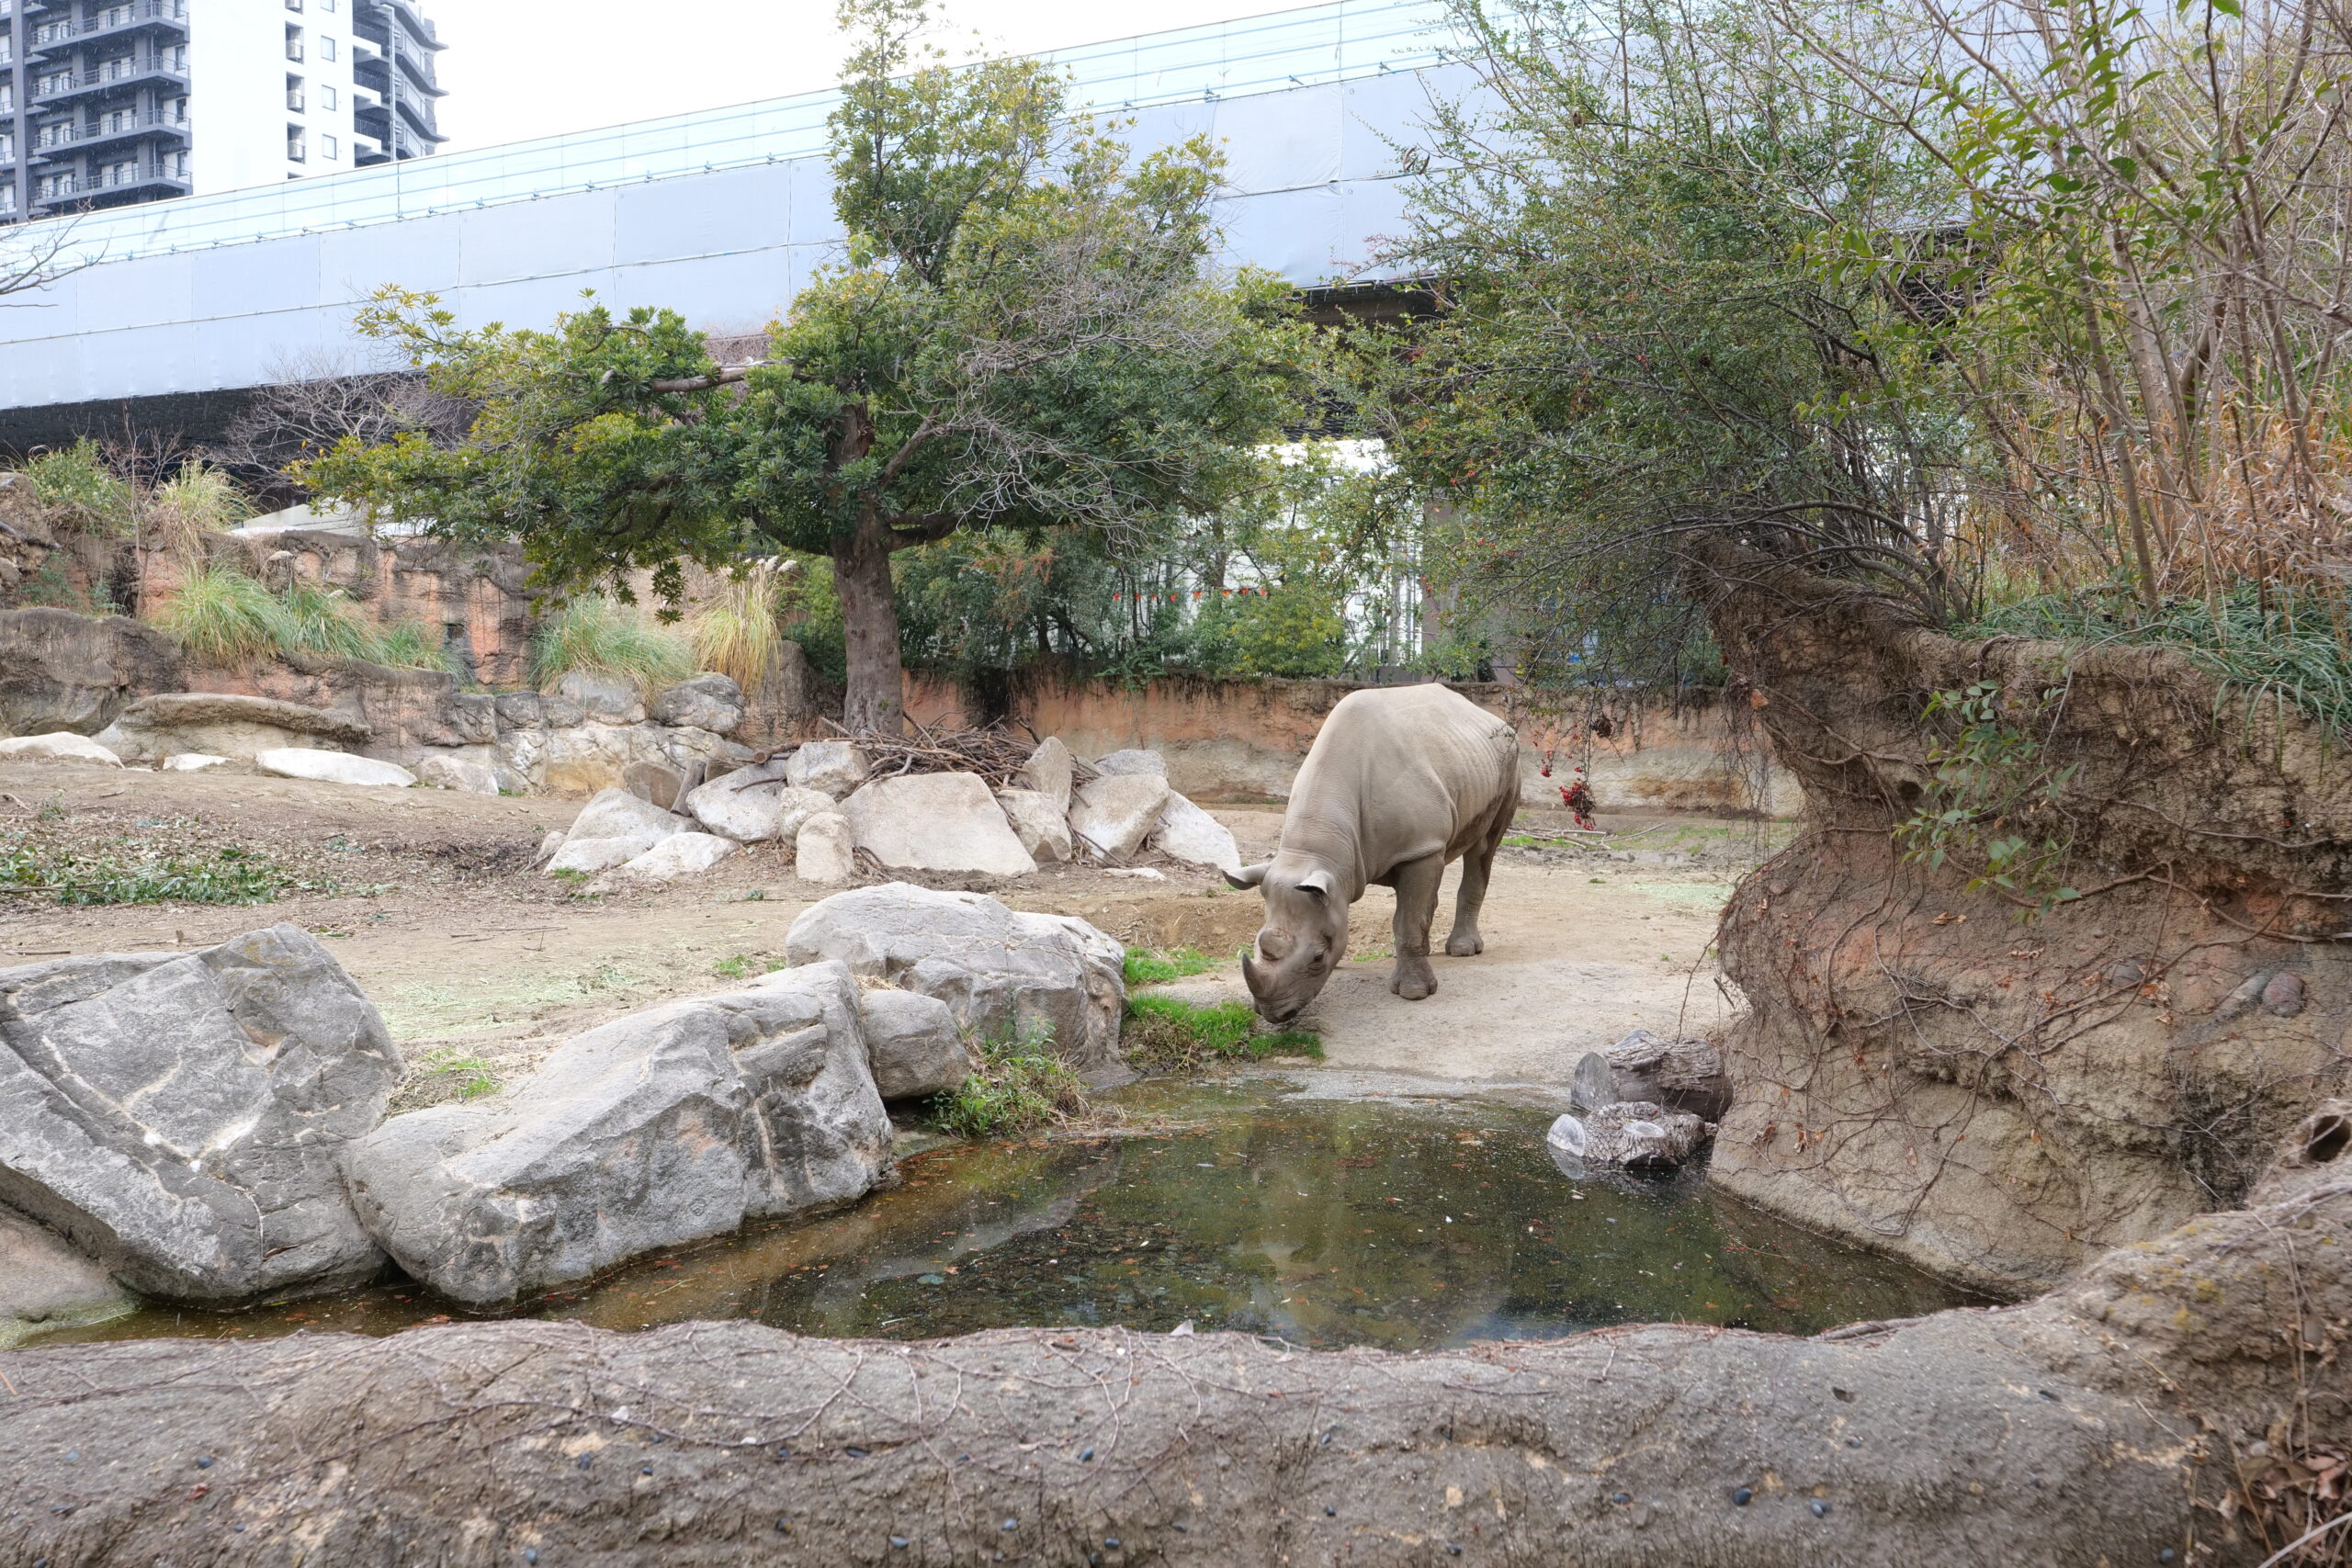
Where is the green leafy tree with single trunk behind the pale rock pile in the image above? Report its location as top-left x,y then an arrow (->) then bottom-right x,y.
299,0 -> 1315,731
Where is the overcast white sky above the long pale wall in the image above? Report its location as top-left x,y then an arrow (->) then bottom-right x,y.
424,0 -> 1303,152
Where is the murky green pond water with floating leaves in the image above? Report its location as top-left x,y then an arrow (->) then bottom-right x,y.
51,1079 -> 1969,1349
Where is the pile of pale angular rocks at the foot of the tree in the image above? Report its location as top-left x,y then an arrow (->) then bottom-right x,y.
526,733 -> 1242,888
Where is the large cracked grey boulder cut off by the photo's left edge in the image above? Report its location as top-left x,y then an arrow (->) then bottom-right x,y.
0,926 -> 402,1304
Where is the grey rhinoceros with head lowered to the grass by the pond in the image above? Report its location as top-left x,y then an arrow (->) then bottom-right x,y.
1226,686 -> 1520,1022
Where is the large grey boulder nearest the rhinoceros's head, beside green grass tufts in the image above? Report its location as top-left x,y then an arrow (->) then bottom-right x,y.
783,882 -> 1126,1072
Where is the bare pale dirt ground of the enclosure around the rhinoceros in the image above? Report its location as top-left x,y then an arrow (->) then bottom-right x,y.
0,761 -> 1788,1107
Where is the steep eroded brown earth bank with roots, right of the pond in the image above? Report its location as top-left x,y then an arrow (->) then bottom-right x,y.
1710,552 -> 2352,1293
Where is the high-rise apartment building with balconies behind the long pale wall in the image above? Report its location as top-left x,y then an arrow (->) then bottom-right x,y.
0,0 -> 445,221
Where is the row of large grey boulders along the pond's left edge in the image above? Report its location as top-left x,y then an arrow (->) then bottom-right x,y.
0,893 -> 1125,1345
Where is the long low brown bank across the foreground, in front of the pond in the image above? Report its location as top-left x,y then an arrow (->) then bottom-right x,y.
0,1107 -> 2352,1568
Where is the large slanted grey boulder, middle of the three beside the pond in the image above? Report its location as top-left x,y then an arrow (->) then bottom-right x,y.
344,964 -> 891,1304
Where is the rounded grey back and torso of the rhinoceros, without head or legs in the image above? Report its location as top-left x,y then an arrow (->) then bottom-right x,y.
1282,684 -> 1520,894
